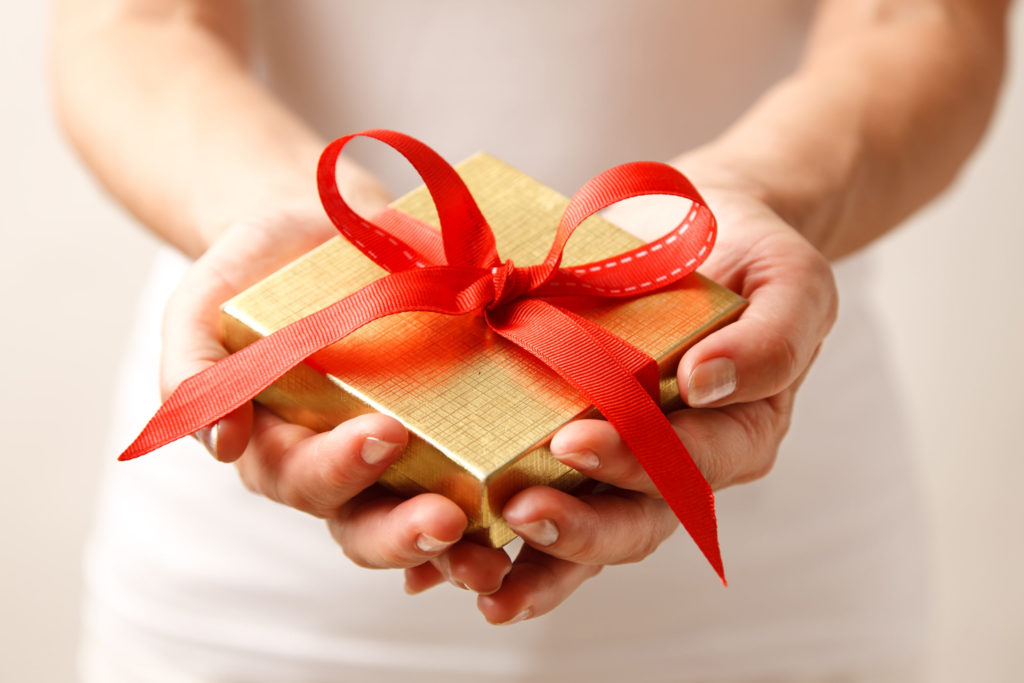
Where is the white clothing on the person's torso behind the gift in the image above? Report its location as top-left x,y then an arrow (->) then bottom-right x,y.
84,0 -> 925,683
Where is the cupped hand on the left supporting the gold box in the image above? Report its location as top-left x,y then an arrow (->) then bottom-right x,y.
161,193 -> 509,592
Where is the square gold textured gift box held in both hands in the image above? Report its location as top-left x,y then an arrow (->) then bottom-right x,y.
222,154 -> 745,547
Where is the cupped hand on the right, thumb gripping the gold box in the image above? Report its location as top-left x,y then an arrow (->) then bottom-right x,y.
466,188 -> 838,624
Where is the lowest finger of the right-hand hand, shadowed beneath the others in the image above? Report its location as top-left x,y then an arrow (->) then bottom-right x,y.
476,546 -> 601,625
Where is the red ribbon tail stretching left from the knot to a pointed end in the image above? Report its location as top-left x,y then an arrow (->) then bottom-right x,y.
118,268 -> 489,460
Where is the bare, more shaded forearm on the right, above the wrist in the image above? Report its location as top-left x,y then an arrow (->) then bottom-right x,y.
678,0 -> 1007,258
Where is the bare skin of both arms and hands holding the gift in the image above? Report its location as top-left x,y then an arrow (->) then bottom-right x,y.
52,0 -> 1010,624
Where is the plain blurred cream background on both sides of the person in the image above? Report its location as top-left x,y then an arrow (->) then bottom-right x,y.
0,2 -> 1024,683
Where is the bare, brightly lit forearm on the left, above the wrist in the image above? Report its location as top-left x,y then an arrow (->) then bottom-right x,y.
53,0 -> 382,256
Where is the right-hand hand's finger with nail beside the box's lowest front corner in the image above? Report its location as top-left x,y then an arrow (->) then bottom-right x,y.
502,486 -> 679,564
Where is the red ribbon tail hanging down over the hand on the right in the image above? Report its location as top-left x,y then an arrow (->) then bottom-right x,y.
487,299 -> 725,584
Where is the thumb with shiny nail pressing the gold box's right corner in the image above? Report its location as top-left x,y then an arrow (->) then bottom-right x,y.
677,233 -> 838,407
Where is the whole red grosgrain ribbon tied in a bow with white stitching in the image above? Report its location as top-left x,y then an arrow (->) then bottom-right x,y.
120,130 -> 724,582
